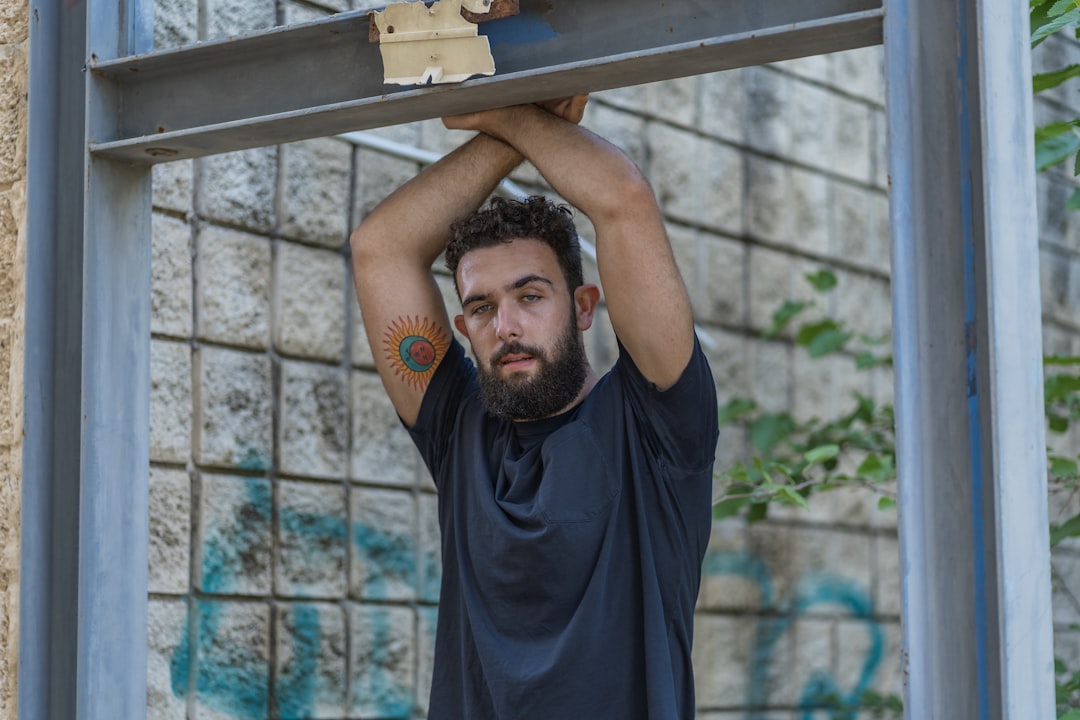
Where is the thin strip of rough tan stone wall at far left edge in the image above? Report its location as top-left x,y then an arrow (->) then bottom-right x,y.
0,0 -> 28,720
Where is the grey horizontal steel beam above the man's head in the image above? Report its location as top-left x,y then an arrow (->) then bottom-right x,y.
84,0 -> 883,162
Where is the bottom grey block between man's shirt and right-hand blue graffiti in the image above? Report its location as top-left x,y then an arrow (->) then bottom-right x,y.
693,614 -> 755,707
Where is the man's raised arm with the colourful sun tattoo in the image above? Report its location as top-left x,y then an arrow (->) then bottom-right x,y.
350,135 -> 522,426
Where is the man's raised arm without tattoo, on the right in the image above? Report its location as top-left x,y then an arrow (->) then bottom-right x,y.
444,105 -> 693,388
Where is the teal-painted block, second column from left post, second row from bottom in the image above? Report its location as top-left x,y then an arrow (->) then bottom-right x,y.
195,475 -> 273,595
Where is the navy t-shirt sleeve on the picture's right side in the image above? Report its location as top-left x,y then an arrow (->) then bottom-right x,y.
615,337 -> 719,473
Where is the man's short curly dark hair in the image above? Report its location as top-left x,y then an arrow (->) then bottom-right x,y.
446,195 -> 584,297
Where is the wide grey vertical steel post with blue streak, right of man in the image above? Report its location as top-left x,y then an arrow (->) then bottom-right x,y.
885,0 -> 1054,720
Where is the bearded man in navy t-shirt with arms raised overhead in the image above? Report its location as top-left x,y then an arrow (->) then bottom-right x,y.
351,96 -> 717,720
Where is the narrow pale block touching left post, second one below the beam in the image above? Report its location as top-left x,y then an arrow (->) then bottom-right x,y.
150,214 -> 193,338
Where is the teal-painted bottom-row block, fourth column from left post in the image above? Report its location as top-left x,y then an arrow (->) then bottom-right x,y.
349,604 -> 416,720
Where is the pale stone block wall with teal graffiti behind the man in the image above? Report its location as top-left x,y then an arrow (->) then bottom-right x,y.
141,0 -> 1080,720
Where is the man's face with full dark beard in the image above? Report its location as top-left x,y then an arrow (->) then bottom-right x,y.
456,240 -> 593,420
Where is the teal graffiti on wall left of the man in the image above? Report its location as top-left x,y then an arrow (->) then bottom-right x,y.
170,478 -> 440,720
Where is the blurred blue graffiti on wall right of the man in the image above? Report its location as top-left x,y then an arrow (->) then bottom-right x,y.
703,552 -> 885,720
